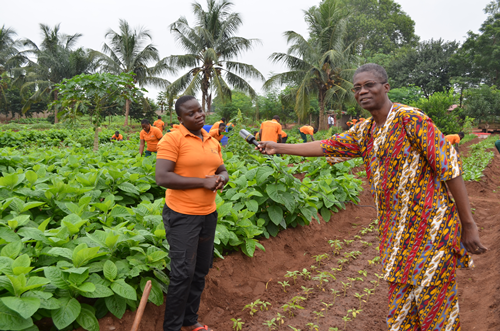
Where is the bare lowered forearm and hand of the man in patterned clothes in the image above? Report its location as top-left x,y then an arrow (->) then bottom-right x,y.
446,176 -> 488,254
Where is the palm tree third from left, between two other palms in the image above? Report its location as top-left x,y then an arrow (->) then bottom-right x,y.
96,20 -> 175,125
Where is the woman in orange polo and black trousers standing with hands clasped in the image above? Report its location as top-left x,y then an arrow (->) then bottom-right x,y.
156,96 -> 229,331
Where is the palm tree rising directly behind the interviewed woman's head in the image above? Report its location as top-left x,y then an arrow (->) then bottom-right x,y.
165,0 -> 264,110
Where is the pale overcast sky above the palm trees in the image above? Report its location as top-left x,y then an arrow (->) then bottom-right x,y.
0,0 -> 490,97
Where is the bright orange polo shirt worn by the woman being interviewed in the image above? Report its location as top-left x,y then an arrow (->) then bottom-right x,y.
156,125 -> 224,215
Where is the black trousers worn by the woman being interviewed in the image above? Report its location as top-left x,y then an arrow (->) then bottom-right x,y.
163,205 -> 217,331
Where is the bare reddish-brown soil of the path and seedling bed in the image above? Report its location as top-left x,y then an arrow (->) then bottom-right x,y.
83,139 -> 500,331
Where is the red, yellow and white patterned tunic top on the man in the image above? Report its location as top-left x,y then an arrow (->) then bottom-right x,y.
321,103 -> 472,286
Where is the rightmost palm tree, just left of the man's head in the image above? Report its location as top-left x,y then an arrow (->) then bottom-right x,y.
264,0 -> 359,130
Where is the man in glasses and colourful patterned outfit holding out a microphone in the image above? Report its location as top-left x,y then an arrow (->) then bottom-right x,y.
259,64 -> 487,331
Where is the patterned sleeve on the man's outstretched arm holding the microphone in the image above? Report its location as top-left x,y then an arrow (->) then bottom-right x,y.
321,125 -> 361,164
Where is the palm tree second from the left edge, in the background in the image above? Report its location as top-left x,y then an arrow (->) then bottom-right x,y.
14,24 -> 96,123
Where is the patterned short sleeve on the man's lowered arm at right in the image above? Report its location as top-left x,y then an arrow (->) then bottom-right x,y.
402,110 -> 463,182
